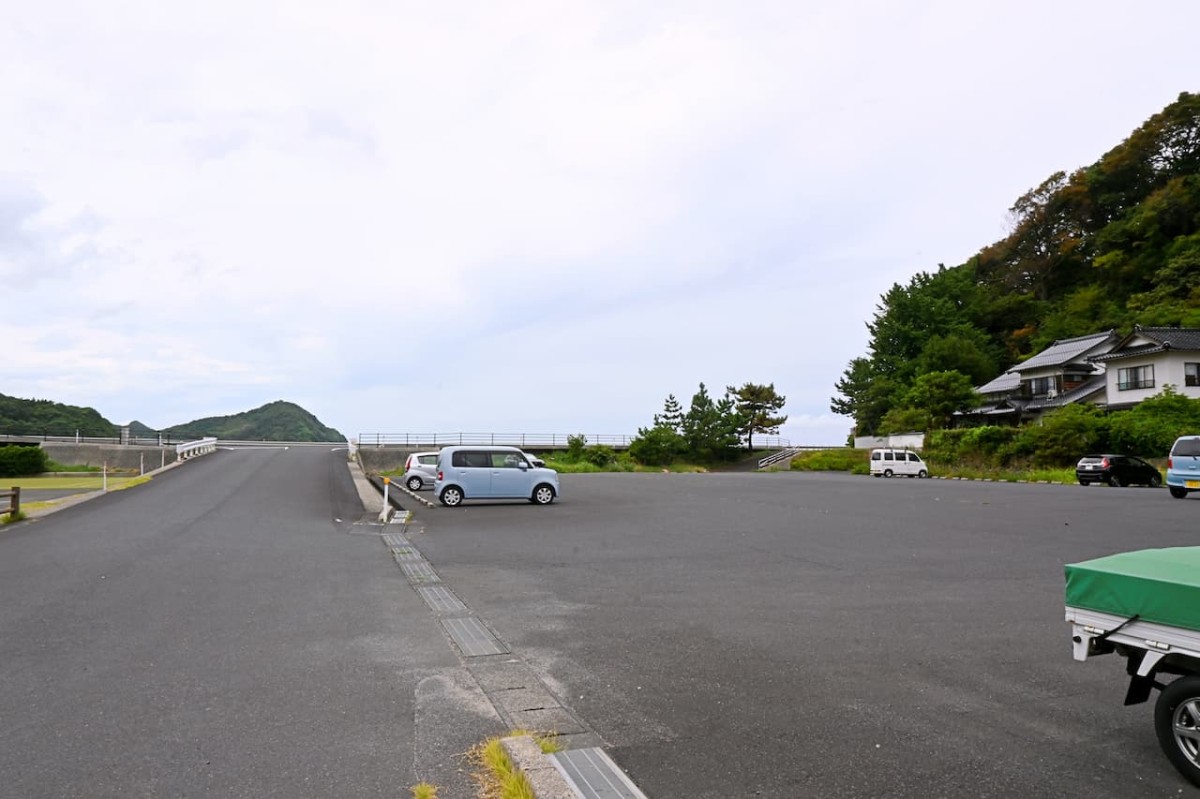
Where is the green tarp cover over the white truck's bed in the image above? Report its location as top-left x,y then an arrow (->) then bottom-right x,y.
1066,547 -> 1200,630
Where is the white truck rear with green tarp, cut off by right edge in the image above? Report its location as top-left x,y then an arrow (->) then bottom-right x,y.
1066,547 -> 1200,786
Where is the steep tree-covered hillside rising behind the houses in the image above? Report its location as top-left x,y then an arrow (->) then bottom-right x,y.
830,92 -> 1200,434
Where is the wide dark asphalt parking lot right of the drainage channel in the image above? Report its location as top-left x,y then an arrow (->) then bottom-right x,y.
410,473 -> 1200,799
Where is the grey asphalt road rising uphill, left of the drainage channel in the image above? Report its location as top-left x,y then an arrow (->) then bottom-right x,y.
0,447 -> 500,799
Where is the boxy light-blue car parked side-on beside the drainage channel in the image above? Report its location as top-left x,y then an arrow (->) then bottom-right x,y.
433,446 -> 558,507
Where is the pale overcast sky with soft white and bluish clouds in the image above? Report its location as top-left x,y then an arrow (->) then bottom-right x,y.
0,0 -> 1200,444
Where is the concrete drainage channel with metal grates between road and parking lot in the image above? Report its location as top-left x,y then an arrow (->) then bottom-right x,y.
380,523 -> 646,799
